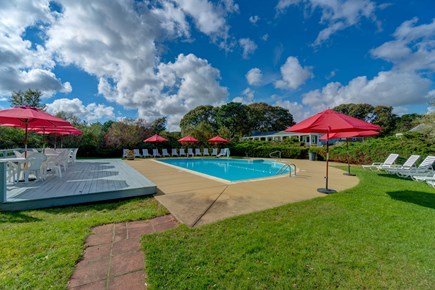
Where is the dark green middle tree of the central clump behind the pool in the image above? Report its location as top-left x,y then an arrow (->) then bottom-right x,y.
217,102 -> 250,138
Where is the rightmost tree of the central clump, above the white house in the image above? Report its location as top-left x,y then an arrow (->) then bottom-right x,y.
248,103 -> 294,132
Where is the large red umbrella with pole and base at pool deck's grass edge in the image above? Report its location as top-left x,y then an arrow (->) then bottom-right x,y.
285,109 -> 382,193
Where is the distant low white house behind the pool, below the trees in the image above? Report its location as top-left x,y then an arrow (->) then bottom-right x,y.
242,131 -> 323,146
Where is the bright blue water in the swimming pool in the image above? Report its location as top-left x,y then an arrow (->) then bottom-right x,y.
160,158 -> 289,181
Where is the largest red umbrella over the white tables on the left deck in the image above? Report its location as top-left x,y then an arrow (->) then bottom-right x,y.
0,106 -> 71,157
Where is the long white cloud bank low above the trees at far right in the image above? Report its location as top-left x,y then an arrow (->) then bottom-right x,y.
302,71 -> 431,112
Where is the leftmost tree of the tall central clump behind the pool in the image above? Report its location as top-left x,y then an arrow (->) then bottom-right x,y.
180,106 -> 218,135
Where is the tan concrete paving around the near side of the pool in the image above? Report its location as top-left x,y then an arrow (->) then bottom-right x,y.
126,159 -> 359,227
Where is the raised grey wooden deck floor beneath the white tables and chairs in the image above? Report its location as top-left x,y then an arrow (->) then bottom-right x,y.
0,159 -> 156,211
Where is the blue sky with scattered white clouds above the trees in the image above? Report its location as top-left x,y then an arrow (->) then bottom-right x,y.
0,0 -> 435,130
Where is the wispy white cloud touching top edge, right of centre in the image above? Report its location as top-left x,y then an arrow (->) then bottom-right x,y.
276,0 -> 380,45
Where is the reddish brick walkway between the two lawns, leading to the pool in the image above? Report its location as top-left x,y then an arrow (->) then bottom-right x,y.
68,215 -> 178,290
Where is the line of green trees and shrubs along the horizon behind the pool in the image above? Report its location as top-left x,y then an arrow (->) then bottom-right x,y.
0,90 -> 435,157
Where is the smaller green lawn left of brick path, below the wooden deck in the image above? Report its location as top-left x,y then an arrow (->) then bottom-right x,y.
0,198 -> 167,289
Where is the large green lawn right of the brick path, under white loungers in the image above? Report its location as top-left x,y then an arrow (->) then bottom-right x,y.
142,169 -> 435,289
